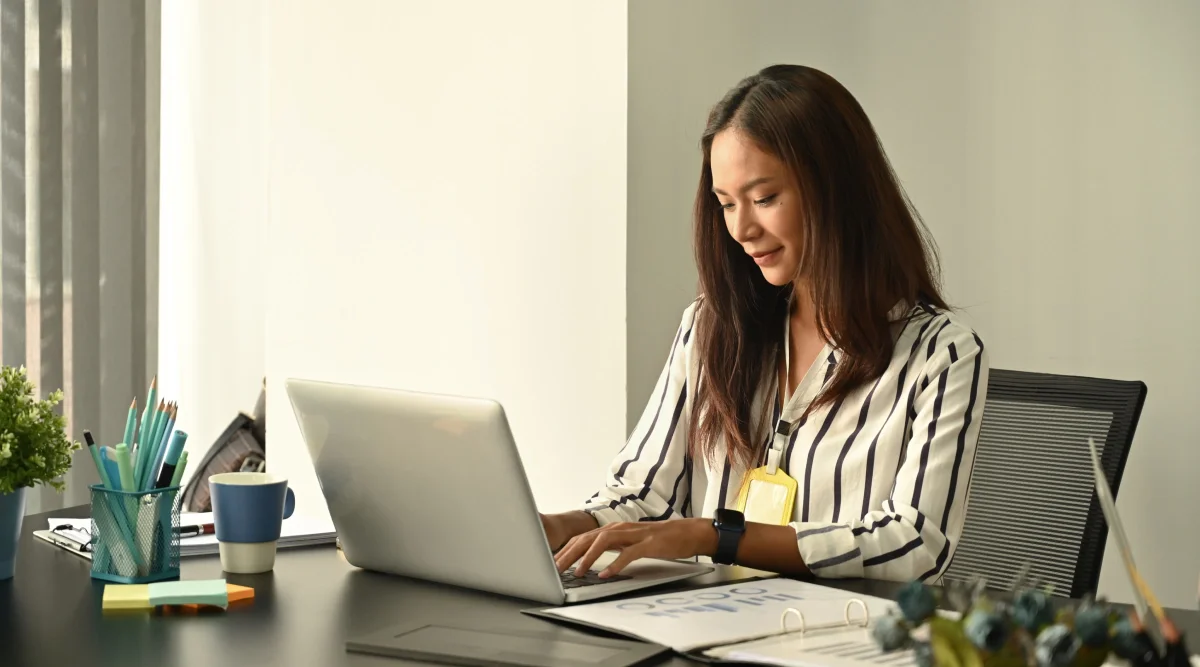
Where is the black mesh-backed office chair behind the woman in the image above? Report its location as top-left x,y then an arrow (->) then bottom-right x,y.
943,369 -> 1146,597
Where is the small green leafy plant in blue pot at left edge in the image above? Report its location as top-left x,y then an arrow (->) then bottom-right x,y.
0,366 -> 79,581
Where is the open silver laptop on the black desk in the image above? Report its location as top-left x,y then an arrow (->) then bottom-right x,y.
286,379 -> 713,605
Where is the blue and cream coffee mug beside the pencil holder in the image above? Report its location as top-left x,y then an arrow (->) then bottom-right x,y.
209,473 -> 296,575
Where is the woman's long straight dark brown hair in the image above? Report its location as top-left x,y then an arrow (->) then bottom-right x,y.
689,65 -> 948,465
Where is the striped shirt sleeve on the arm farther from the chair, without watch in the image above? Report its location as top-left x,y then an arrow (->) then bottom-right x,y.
582,304 -> 697,525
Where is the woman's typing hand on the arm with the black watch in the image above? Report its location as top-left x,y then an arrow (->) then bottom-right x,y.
554,518 -> 716,577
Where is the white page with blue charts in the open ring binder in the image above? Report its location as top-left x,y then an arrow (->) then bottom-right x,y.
541,578 -> 895,653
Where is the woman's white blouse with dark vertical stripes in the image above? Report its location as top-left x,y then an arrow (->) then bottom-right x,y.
582,301 -> 988,582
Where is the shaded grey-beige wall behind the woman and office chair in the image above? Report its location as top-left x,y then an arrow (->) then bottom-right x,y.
629,0 -> 1200,607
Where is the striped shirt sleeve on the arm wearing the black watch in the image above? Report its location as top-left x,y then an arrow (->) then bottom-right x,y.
792,319 -> 989,582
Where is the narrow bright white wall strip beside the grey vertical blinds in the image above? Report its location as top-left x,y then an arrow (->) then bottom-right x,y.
158,0 -> 266,476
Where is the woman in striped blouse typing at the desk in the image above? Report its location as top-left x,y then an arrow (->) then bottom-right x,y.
542,65 -> 988,581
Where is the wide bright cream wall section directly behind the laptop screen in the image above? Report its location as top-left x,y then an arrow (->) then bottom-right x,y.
261,0 -> 626,511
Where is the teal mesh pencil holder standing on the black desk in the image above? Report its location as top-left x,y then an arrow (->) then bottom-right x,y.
91,485 -> 179,583
